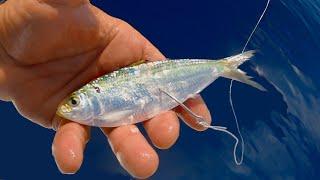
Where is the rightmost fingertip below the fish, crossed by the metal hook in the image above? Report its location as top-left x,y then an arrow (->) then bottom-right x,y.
175,95 -> 211,131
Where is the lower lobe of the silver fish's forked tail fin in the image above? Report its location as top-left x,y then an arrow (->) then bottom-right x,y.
222,69 -> 267,91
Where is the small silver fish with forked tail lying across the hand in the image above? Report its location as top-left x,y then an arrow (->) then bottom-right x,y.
57,51 -> 265,127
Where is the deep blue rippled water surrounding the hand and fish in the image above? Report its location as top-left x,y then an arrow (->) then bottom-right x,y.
0,0 -> 320,179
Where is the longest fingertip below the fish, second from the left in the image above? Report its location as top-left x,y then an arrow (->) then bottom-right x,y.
102,125 -> 159,178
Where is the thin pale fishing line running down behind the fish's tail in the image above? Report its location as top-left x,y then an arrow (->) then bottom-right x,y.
229,0 -> 270,165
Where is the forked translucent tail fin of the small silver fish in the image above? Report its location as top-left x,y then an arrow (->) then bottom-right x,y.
222,51 -> 266,91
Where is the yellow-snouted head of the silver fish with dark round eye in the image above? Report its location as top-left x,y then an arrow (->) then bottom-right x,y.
57,92 -> 92,124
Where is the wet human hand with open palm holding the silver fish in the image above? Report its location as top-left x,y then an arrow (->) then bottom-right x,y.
0,0 -> 211,178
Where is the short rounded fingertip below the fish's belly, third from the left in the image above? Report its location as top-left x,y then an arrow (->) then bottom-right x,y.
143,111 -> 180,149
